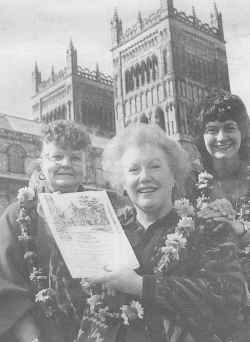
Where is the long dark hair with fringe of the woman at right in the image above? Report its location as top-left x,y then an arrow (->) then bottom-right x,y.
191,90 -> 250,171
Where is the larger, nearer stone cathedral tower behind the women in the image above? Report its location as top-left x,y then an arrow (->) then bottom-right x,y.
111,0 -> 230,152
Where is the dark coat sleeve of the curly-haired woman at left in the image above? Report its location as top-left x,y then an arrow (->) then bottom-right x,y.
0,203 -> 34,337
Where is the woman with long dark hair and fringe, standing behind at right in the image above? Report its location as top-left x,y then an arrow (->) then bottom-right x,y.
191,91 -> 250,242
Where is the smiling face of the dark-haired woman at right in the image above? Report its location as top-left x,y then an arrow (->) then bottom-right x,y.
203,120 -> 241,159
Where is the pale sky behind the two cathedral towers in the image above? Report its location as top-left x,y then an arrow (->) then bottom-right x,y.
0,0 -> 250,118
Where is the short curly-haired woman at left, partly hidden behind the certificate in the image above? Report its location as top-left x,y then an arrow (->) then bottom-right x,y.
0,120 -> 90,342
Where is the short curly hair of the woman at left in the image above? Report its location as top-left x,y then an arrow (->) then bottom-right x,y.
41,120 -> 91,150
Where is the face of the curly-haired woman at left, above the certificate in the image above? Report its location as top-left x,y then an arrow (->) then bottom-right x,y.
41,142 -> 84,192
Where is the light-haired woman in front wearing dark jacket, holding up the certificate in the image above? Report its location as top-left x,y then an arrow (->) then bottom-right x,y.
79,124 -> 246,342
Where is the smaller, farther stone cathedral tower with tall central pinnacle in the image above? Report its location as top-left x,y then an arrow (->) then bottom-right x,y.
32,40 -> 115,138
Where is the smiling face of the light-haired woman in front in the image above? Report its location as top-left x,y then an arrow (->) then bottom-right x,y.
121,144 -> 174,219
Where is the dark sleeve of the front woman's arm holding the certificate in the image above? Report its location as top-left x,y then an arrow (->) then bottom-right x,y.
143,225 -> 246,336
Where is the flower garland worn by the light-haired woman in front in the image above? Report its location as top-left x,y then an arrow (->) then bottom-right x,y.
79,199 -> 195,342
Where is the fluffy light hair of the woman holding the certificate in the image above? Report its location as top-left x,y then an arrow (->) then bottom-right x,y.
103,123 -> 190,189
